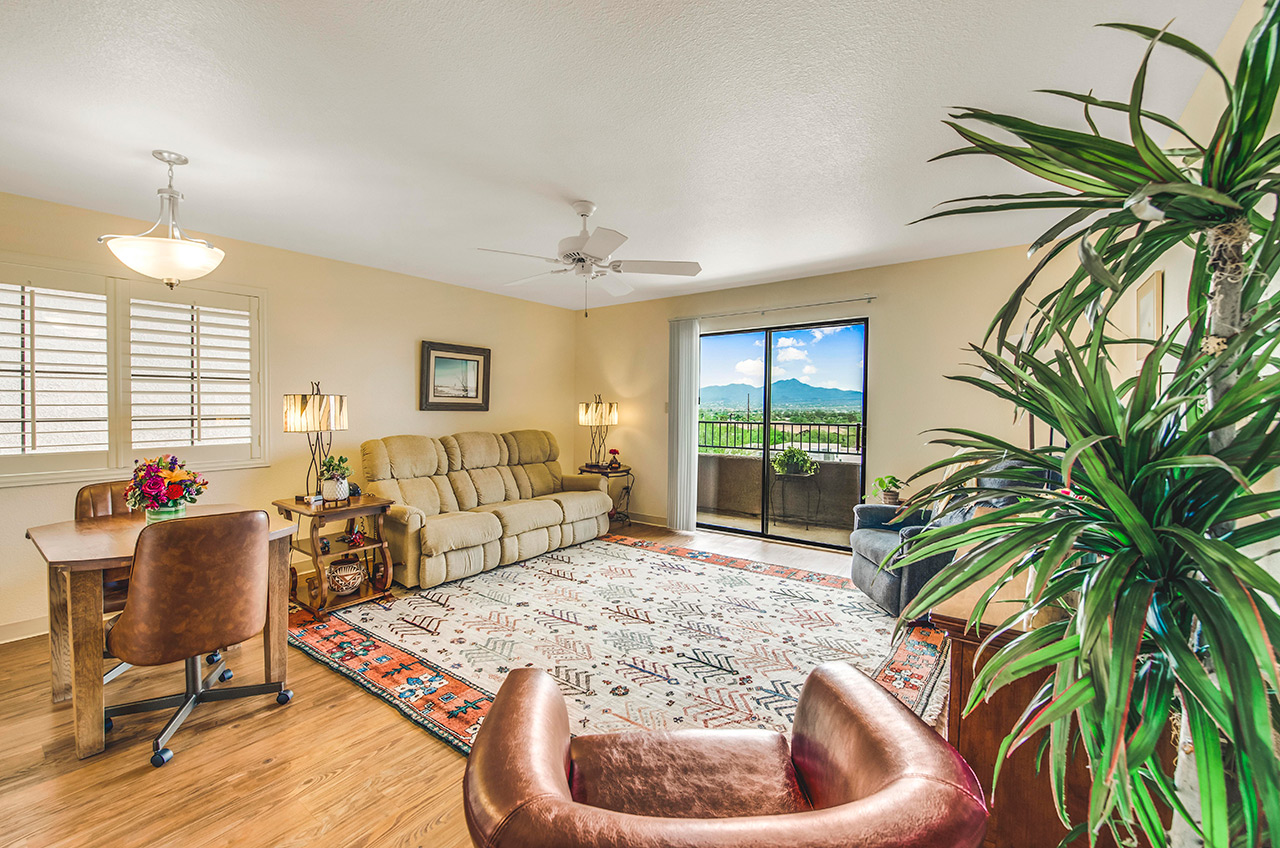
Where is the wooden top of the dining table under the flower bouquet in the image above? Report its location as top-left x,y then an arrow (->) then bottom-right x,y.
27,503 -> 298,571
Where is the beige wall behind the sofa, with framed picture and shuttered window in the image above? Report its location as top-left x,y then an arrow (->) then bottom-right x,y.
0,193 -> 577,640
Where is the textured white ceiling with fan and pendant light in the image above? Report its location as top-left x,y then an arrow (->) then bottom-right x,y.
0,0 -> 1239,306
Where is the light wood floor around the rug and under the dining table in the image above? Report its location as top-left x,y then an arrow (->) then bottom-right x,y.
0,524 -> 849,848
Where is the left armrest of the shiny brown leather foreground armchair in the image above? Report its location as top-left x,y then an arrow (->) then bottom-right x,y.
462,669 -> 573,845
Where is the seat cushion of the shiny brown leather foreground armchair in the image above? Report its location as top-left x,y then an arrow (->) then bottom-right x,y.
570,730 -> 810,819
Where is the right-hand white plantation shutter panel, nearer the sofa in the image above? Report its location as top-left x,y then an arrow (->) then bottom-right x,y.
129,284 -> 259,461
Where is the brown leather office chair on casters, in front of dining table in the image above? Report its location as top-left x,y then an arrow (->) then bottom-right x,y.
104,510 -> 293,767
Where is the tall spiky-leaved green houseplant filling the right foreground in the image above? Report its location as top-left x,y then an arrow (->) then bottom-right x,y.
901,0 -> 1280,848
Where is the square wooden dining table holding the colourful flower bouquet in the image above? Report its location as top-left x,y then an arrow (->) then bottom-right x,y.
27,503 -> 298,760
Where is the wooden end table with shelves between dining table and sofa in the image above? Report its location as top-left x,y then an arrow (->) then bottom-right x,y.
271,494 -> 394,621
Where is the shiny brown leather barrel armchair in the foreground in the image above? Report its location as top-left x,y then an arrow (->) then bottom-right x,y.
463,662 -> 987,848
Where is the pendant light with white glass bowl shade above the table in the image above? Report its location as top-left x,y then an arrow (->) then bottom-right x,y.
97,150 -> 225,288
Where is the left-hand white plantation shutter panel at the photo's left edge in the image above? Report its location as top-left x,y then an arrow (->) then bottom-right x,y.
0,263 -> 110,474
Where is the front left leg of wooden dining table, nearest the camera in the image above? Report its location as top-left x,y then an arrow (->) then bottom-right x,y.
68,571 -> 105,760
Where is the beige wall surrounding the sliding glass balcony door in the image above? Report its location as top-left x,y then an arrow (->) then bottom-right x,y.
576,247 -> 1085,520
